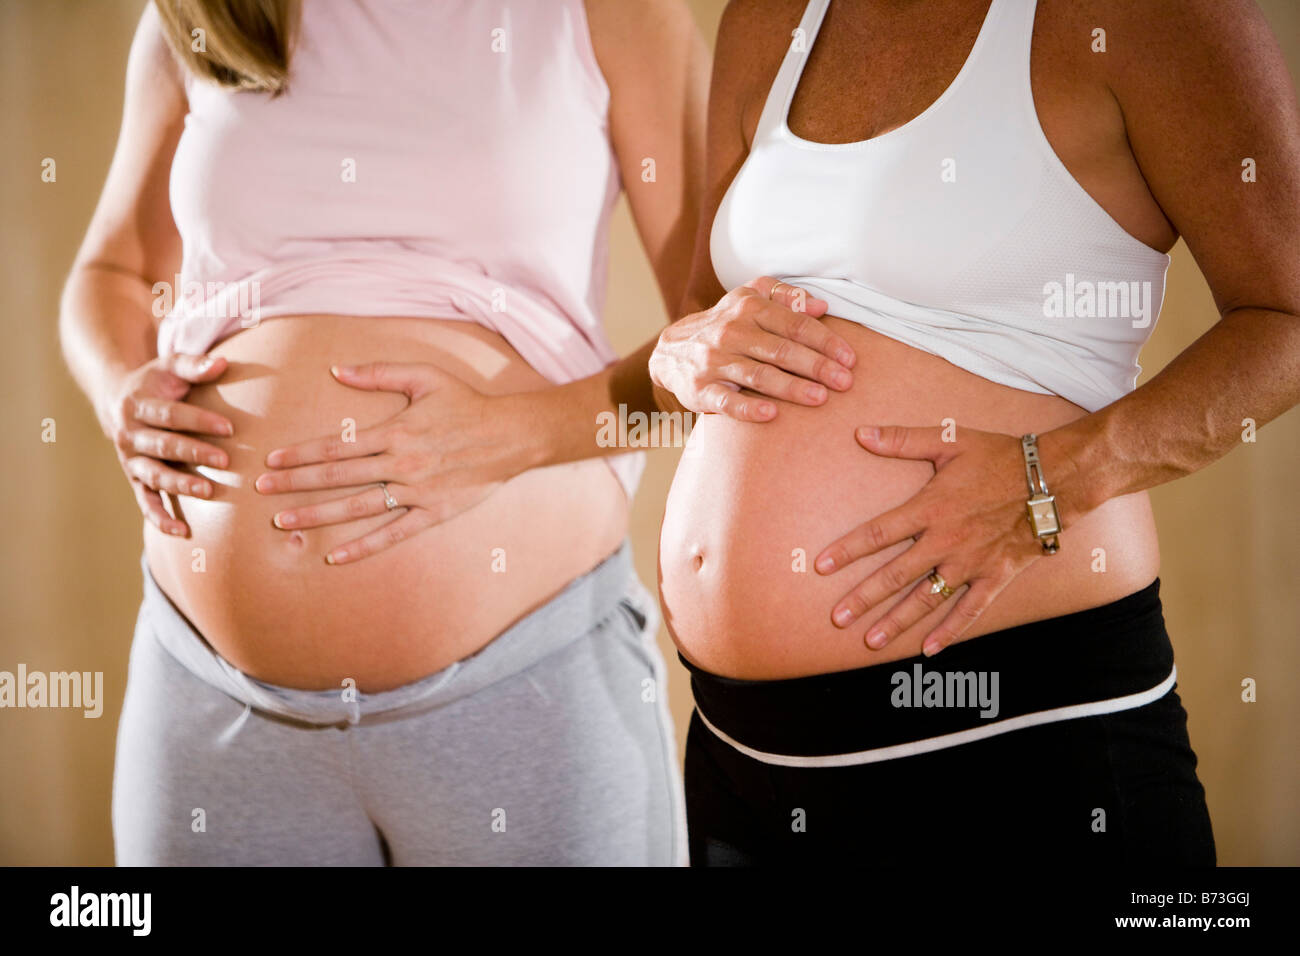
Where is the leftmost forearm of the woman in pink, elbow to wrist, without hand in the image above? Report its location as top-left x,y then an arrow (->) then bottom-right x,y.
59,265 -> 157,429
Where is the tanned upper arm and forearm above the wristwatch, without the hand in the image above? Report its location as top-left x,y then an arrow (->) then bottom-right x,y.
1041,0 -> 1300,520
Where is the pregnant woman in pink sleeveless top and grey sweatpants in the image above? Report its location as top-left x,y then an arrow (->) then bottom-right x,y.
61,0 -> 842,865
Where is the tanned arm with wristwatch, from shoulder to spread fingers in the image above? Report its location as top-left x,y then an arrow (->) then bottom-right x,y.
816,0 -> 1300,654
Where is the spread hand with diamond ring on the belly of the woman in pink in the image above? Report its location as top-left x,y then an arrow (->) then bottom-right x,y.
255,363 -> 532,564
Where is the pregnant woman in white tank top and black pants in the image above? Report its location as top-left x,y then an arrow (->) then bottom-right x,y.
651,0 -> 1300,868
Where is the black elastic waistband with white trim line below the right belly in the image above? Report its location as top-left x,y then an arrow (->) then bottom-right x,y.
679,579 -> 1177,766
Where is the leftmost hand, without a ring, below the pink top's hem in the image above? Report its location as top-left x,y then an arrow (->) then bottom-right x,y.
104,355 -> 234,536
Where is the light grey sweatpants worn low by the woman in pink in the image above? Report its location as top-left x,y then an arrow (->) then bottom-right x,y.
113,542 -> 685,865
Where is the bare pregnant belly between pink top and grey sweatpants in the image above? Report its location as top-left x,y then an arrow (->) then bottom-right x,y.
144,316 -> 627,691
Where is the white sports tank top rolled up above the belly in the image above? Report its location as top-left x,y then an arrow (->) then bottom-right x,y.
710,0 -> 1169,411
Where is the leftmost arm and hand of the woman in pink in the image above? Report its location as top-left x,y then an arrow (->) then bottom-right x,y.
59,4 -> 231,535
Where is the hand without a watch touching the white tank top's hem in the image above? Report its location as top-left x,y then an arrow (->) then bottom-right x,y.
650,276 -> 857,421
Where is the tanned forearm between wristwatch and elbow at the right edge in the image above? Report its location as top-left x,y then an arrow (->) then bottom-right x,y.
1039,308 -> 1300,527
